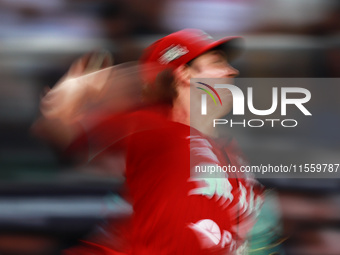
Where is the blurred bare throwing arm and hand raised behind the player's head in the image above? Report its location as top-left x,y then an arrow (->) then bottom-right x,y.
31,51 -> 112,150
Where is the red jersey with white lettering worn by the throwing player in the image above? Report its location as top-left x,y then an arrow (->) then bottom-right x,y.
61,105 -> 262,255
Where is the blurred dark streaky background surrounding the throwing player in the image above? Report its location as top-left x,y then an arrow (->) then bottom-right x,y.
0,0 -> 340,255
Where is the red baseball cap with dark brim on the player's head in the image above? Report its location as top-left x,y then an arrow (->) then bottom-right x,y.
140,29 -> 244,82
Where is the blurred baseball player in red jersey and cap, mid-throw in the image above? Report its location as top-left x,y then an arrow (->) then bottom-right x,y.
38,29 -> 263,255
